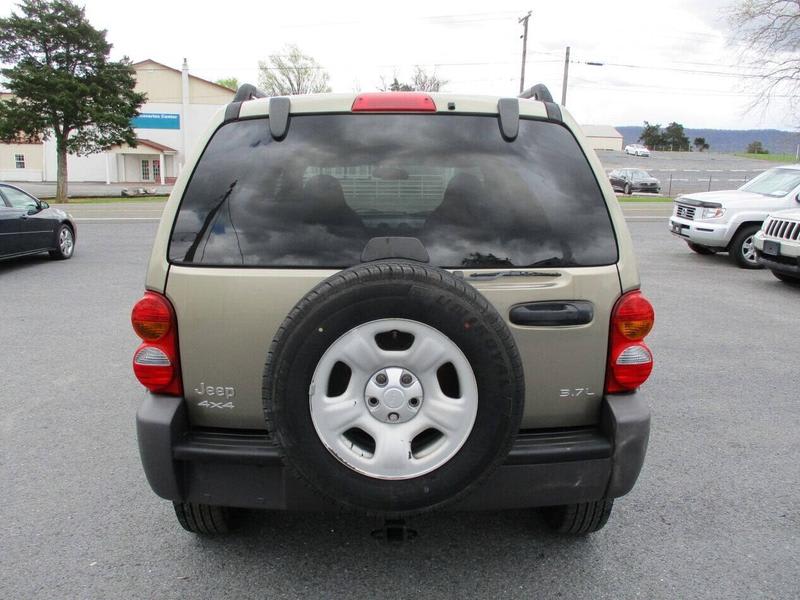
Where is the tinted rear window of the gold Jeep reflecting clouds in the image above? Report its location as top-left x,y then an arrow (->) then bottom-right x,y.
169,115 -> 617,268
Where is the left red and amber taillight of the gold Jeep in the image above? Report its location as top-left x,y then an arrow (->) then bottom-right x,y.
131,292 -> 183,396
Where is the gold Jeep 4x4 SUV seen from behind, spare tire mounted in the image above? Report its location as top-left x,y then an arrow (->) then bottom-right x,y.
132,86 -> 654,534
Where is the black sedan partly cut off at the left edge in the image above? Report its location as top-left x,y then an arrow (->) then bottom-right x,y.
0,183 -> 78,260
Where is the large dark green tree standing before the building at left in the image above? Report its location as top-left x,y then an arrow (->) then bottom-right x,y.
0,0 -> 145,202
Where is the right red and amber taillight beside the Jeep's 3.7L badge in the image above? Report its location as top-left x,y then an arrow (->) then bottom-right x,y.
606,290 -> 655,394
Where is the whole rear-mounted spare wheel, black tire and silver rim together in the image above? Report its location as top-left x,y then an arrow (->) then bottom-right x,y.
264,260 -> 525,514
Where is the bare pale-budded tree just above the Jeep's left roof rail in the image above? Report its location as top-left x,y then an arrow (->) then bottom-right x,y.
258,44 -> 331,96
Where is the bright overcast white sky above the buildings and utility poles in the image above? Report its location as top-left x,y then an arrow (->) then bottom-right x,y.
0,0 -> 795,130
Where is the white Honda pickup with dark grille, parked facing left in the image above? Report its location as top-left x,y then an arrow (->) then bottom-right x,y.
669,164 -> 800,269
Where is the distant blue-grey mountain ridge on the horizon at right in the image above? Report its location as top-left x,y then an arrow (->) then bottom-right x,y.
616,125 -> 800,154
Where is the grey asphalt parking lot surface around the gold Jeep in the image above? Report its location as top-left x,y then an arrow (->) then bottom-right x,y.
0,221 -> 800,599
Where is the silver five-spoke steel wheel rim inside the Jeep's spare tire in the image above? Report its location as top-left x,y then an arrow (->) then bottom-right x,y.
309,319 -> 478,479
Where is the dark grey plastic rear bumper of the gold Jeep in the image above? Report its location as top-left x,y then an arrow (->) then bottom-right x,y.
136,393 -> 650,510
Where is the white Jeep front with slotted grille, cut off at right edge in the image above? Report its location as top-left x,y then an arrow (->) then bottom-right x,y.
754,208 -> 800,284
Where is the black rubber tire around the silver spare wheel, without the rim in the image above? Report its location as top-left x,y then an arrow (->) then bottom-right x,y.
265,264 -> 524,513
